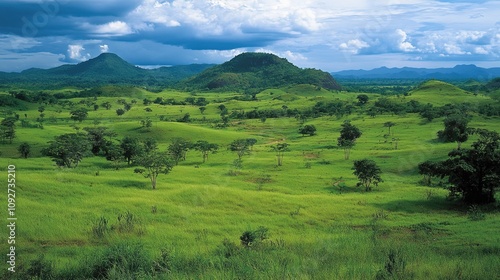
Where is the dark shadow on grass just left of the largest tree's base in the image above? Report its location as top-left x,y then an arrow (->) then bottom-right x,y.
371,197 -> 459,213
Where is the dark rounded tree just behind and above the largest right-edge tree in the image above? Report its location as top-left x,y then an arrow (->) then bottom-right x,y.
437,114 -> 469,149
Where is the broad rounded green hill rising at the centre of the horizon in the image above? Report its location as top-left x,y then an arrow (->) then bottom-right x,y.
178,53 -> 341,92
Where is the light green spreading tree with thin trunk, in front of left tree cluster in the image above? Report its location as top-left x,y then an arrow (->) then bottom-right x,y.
134,151 -> 174,190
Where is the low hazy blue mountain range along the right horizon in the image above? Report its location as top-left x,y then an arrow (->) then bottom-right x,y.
332,65 -> 500,81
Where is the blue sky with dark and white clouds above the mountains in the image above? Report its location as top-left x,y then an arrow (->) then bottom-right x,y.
0,0 -> 500,72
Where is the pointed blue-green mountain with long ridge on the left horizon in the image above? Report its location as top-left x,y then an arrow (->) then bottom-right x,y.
0,53 -> 213,87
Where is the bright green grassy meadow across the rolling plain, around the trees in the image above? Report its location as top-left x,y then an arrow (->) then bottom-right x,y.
0,84 -> 500,279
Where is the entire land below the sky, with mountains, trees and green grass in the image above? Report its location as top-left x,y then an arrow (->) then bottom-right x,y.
0,53 -> 500,279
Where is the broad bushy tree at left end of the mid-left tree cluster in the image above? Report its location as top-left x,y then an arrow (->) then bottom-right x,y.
42,133 -> 92,168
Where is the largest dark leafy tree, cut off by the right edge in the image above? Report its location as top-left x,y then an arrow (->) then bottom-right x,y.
430,129 -> 500,204
